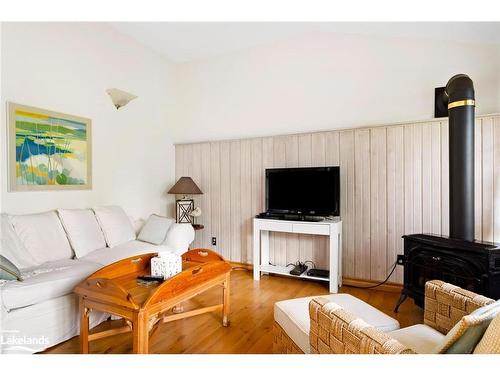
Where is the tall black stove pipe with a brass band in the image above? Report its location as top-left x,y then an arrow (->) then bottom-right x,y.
445,74 -> 475,241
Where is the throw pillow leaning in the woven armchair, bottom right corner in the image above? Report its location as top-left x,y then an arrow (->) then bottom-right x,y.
434,301 -> 500,354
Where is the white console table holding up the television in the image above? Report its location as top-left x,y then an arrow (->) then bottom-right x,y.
253,218 -> 342,293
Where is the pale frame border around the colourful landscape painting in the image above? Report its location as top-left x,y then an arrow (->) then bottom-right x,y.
7,102 -> 92,192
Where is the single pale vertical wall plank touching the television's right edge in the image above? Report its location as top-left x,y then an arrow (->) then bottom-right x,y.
339,130 -> 356,277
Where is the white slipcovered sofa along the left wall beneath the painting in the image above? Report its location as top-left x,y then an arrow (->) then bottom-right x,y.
0,206 -> 194,353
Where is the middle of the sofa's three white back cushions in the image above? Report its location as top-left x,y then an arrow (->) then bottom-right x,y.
57,209 -> 106,258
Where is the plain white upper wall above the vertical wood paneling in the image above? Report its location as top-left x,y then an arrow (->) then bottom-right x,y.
173,33 -> 500,143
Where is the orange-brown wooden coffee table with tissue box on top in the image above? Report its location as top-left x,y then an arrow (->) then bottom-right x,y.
74,249 -> 231,354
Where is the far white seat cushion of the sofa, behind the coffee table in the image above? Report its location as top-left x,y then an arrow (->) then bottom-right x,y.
82,241 -> 164,266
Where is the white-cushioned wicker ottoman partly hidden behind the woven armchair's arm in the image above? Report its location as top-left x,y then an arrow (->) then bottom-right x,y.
274,294 -> 399,353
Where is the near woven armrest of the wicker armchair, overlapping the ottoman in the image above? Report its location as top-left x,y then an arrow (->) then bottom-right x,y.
309,297 -> 413,354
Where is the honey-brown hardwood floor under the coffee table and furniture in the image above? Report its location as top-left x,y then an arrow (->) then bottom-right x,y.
45,270 -> 423,354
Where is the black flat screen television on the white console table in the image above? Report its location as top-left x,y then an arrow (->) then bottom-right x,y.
266,167 -> 340,216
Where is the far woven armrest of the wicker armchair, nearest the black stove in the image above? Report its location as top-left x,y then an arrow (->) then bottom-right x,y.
424,280 -> 494,334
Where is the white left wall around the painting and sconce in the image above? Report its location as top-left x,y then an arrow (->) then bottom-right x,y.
1,23 -> 175,217
